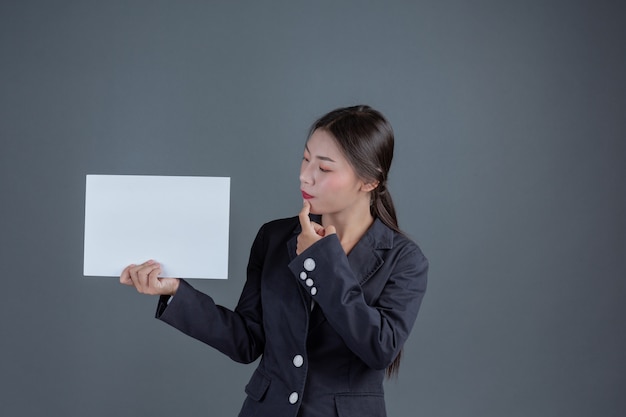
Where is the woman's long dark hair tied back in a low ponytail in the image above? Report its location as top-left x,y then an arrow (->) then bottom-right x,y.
309,105 -> 402,377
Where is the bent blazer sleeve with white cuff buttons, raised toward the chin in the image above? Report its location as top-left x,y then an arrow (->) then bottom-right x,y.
289,235 -> 428,369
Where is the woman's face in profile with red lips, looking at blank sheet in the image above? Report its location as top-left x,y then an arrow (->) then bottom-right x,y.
300,129 -> 371,215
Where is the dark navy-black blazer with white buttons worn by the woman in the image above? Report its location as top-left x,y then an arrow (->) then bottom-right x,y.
157,217 -> 428,417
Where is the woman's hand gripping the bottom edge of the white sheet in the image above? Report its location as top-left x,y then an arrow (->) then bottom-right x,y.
120,260 -> 180,295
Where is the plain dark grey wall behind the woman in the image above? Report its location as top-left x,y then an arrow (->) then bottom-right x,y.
0,0 -> 626,417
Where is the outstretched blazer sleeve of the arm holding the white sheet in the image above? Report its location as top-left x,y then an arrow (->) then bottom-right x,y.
156,223 -> 265,363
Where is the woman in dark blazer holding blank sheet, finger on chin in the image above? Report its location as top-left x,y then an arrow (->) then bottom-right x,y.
120,106 -> 428,417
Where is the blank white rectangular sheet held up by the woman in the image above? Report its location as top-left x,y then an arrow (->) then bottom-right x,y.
83,175 -> 230,279
